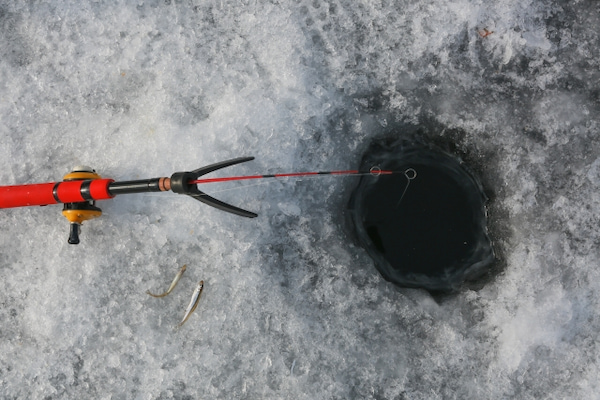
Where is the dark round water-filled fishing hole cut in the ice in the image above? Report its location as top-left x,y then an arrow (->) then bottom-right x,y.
349,142 -> 494,292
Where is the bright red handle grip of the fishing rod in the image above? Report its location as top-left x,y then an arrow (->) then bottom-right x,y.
0,179 -> 114,208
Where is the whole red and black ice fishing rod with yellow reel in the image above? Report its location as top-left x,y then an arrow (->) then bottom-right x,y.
0,157 -> 406,244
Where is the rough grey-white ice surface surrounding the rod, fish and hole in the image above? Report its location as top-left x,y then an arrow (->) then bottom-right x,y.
0,0 -> 600,399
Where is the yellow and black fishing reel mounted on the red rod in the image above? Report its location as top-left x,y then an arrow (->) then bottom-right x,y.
63,165 -> 102,244
